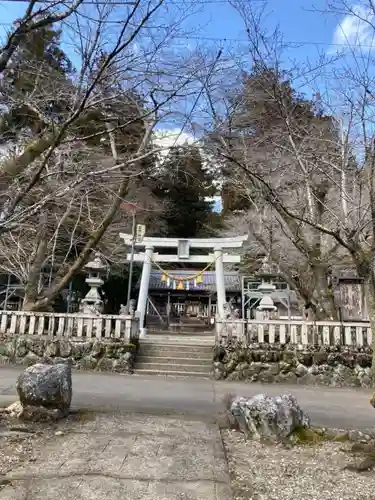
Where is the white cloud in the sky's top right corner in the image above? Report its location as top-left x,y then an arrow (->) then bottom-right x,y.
332,4 -> 375,51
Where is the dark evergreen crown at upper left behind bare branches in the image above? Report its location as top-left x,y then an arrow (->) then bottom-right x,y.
0,27 -> 74,141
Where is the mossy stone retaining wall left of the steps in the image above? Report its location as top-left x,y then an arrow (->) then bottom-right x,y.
0,335 -> 138,373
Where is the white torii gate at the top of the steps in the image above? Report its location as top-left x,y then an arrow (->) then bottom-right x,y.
120,233 -> 248,337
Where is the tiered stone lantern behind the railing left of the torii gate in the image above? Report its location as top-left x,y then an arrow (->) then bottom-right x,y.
80,253 -> 107,315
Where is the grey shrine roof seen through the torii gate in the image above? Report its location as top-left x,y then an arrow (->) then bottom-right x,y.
137,269 -> 241,293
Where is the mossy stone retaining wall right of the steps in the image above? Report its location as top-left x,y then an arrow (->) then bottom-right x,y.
213,343 -> 372,387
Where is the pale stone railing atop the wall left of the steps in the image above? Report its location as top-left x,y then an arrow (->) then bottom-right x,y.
0,311 -> 139,342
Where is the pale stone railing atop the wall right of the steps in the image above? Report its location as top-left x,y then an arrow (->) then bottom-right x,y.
216,320 -> 372,347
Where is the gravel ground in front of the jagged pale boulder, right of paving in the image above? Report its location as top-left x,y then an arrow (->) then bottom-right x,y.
222,430 -> 375,500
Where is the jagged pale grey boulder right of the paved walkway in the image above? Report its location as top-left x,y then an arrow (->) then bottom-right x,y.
230,394 -> 310,441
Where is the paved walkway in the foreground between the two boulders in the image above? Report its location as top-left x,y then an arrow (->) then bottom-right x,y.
0,413 -> 231,500
